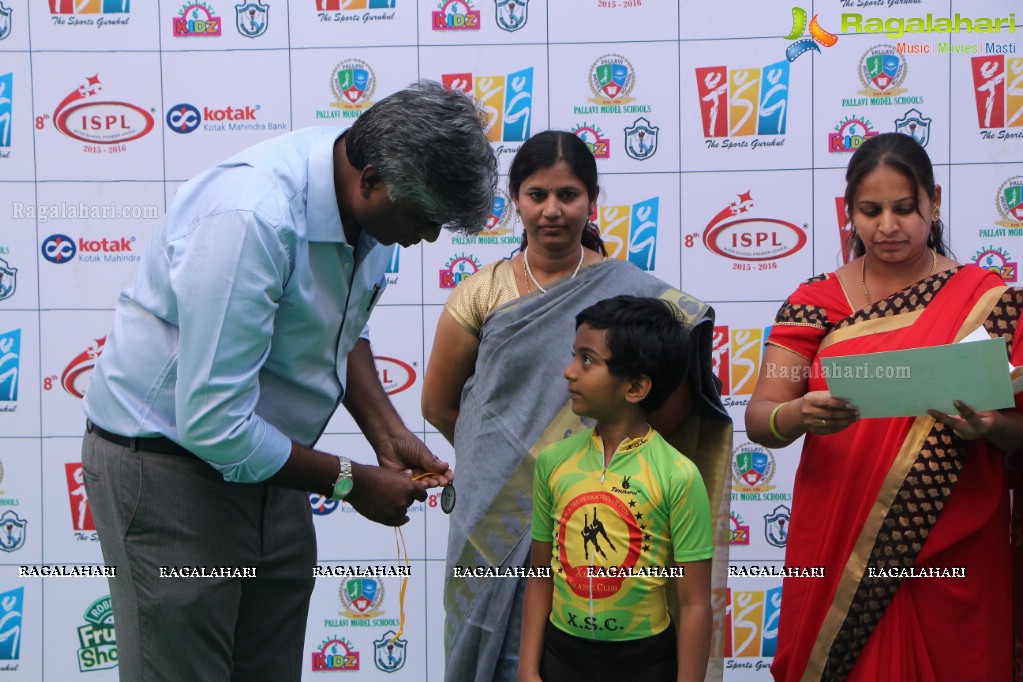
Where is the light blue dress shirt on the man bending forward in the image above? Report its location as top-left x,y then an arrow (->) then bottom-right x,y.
84,128 -> 392,483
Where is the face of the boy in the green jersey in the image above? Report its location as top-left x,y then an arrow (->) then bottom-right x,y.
563,323 -> 630,421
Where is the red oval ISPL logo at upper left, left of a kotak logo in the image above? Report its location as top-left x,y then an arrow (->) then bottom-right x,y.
50,74 -> 155,148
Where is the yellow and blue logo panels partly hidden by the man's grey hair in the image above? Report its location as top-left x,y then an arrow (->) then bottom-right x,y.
441,66 -> 533,142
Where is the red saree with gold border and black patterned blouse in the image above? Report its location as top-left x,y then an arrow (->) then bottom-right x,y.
768,266 -> 1023,682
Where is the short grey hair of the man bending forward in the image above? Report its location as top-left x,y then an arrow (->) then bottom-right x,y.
345,81 -> 497,234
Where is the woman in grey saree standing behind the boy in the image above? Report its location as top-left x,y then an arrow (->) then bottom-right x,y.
424,132 -> 731,682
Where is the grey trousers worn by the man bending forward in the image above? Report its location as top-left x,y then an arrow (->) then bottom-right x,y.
82,433 -> 316,682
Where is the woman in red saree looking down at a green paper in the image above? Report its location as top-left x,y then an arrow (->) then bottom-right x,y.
746,133 -> 1023,682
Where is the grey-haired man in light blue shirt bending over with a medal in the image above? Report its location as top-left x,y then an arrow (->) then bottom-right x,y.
82,82 -> 496,682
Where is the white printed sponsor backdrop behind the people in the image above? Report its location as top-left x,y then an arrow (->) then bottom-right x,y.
0,0 -> 1023,682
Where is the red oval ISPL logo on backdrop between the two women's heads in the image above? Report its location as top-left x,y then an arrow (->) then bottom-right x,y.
686,191 -> 807,261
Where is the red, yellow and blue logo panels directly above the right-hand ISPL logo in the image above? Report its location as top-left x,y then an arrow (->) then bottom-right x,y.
696,61 -> 789,141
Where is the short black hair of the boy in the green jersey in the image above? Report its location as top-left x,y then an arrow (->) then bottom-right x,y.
576,295 -> 690,413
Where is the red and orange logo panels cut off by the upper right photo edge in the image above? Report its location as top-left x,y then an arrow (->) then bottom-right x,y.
970,54 -> 1023,133
